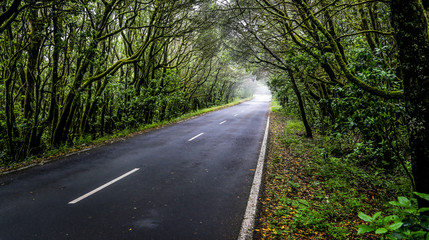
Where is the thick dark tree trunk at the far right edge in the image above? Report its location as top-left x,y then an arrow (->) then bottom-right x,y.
390,0 -> 429,207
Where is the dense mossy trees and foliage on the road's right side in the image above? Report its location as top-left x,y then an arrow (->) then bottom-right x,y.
221,0 -> 429,217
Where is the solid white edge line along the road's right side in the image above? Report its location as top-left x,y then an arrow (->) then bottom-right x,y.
237,117 -> 270,240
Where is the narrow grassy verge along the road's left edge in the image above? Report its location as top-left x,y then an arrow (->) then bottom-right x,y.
0,98 -> 251,174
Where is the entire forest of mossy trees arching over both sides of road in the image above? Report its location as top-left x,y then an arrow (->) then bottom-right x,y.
0,0 -> 429,238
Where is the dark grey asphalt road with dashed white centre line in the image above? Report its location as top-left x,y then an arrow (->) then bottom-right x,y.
0,90 -> 269,240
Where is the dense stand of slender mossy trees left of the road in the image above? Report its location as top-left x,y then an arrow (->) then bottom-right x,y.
0,0 -> 252,165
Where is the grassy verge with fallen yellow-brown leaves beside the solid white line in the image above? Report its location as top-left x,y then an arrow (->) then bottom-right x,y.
255,101 -> 408,239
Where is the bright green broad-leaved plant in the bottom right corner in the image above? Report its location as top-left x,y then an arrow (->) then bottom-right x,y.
358,193 -> 429,239
